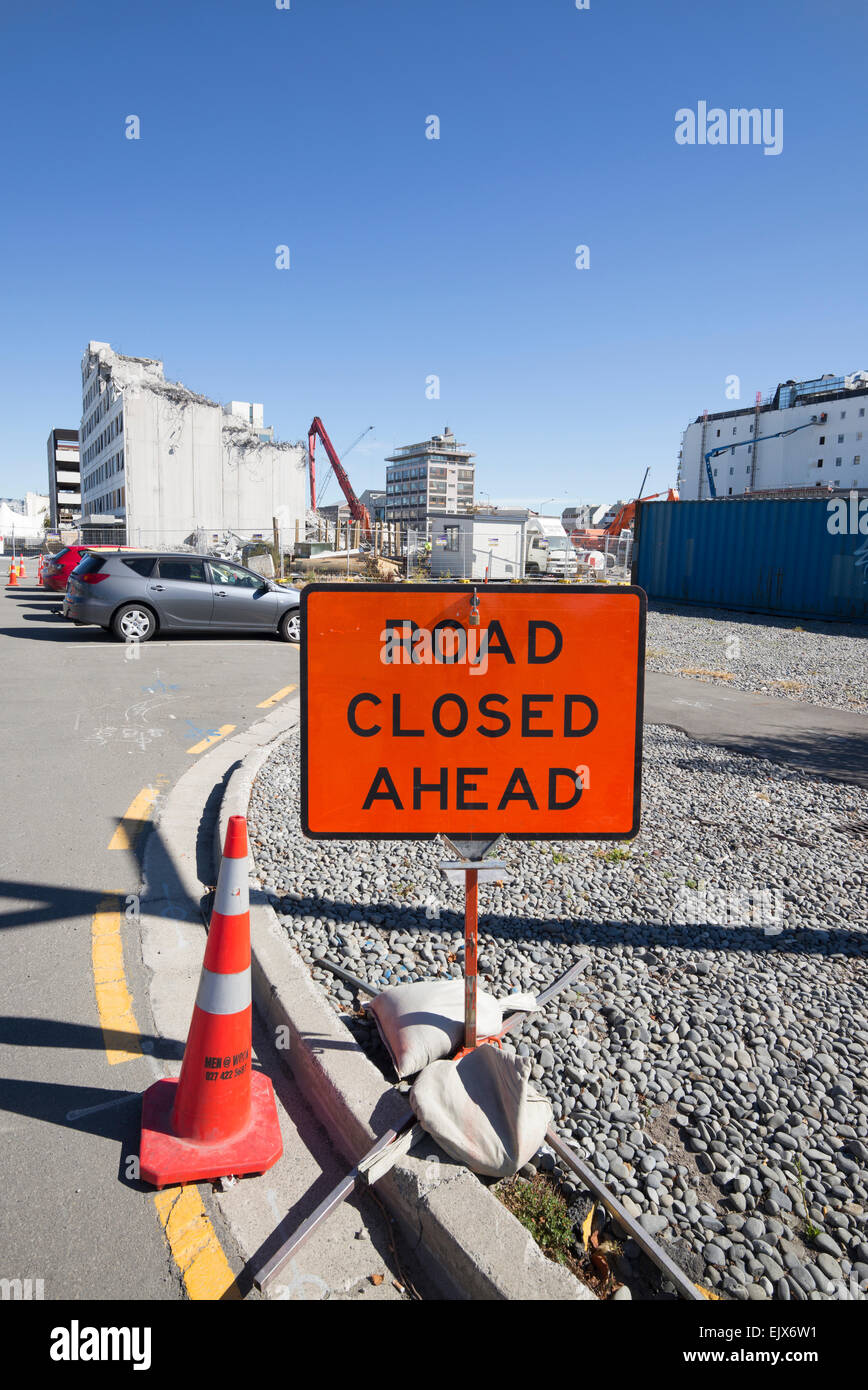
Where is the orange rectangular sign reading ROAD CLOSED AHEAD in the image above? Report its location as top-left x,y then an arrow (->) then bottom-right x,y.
302,584 -> 645,840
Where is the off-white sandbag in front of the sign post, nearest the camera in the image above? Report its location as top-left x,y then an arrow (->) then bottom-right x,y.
410,1045 -> 552,1177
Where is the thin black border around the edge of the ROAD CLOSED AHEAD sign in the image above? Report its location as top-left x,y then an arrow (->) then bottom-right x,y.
299,581 -> 648,841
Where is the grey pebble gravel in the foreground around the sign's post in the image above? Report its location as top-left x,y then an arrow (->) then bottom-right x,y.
249,728 -> 868,1300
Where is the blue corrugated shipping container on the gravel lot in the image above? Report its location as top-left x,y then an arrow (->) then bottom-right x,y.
633,493 -> 868,621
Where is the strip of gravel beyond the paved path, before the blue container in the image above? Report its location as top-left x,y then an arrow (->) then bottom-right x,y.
647,605 -> 868,710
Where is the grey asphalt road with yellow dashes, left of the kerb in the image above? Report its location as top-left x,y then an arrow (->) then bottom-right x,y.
0,581 -> 298,1300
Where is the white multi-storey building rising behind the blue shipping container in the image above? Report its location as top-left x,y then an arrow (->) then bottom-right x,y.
677,371 -> 868,502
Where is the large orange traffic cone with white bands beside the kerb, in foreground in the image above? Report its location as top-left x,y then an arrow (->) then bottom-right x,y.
139,816 -> 284,1187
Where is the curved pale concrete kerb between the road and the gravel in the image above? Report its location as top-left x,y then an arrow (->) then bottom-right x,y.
217,706 -> 595,1301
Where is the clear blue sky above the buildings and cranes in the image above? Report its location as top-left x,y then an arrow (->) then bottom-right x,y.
0,0 -> 868,512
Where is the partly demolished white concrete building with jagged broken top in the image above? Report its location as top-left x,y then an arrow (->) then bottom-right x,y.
81,342 -> 306,548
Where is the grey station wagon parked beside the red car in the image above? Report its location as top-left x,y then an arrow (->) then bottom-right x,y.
63,550 -> 300,642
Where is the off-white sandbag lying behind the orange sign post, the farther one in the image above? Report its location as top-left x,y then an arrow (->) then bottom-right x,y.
364,980 -> 537,1080
